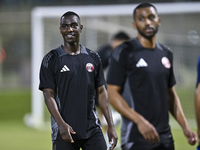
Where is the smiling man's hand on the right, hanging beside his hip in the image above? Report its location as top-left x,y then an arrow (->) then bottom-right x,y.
107,127 -> 118,150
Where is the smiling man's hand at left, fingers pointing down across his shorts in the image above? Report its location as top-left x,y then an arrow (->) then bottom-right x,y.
59,123 -> 76,143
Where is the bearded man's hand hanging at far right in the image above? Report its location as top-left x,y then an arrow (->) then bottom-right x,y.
183,127 -> 197,145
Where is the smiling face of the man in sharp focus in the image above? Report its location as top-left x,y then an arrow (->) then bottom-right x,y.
60,15 -> 83,43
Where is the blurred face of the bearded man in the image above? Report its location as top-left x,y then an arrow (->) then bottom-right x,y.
133,7 -> 160,39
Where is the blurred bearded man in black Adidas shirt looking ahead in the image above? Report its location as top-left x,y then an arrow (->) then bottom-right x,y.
107,3 -> 197,150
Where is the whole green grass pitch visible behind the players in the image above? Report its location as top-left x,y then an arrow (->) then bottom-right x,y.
0,90 -> 197,150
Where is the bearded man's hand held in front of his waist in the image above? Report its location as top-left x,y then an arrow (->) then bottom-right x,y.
137,118 -> 160,144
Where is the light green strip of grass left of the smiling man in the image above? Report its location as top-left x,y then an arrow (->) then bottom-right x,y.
0,121 -> 51,150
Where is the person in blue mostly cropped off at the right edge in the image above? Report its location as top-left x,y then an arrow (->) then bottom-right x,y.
195,56 -> 200,150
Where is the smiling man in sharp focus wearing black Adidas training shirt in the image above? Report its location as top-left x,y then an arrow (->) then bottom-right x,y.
39,11 -> 118,150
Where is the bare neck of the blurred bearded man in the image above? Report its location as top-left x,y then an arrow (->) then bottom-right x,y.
138,35 -> 156,49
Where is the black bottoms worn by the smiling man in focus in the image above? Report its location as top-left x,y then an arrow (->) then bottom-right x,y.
53,132 -> 107,150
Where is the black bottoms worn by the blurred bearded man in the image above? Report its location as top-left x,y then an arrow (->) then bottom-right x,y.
122,132 -> 174,150
